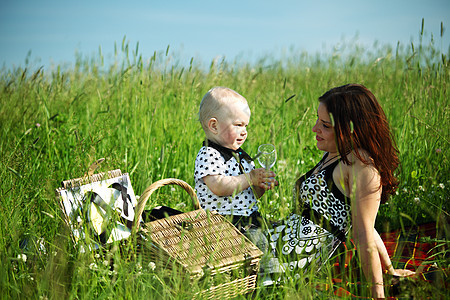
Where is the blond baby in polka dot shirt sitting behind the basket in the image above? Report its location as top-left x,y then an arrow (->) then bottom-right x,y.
194,87 -> 278,232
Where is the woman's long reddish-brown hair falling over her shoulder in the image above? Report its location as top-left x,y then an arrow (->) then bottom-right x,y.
319,84 -> 399,203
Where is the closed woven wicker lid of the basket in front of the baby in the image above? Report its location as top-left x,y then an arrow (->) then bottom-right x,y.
143,209 -> 263,276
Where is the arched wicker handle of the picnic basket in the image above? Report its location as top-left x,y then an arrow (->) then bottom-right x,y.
134,178 -> 200,230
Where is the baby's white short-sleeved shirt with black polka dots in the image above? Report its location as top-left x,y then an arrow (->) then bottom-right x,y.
194,143 -> 258,216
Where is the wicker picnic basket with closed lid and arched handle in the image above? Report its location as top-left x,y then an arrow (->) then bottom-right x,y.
135,178 -> 263,299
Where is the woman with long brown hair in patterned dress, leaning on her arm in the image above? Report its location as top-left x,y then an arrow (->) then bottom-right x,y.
270,84 -> 413,298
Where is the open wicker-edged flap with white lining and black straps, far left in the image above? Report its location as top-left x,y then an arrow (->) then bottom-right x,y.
57,170 -> 137,248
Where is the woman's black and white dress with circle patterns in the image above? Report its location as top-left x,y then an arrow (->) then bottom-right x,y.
267,155 -> 351,273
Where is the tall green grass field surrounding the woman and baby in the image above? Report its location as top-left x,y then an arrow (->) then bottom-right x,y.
0,25 -> 450,299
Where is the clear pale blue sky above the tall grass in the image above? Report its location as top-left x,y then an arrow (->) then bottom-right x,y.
0,0 -> 450,68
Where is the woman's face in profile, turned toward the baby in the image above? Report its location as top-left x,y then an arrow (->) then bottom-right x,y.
312,102 -> 337,153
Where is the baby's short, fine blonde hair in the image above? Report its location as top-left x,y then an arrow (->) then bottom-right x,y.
198,86 -> 247,132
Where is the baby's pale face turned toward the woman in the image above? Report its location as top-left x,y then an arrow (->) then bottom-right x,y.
215,101 -> 250,150
